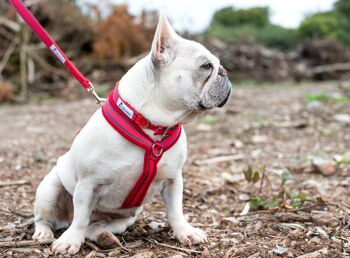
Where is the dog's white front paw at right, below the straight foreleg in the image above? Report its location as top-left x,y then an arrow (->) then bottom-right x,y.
174,223 -> 208,245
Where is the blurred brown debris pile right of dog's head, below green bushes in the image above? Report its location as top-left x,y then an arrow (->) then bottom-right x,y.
205,40 -> 350,82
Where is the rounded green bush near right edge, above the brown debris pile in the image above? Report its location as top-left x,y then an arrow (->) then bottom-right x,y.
297,12 -> 339,39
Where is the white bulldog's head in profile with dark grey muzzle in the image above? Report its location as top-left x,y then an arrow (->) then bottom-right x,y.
151,14 -> 231,114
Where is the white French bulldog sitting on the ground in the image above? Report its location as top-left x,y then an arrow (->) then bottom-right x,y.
33,15 -> 231,255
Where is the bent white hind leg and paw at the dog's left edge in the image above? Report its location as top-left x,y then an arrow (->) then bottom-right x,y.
33,166 -> 69,239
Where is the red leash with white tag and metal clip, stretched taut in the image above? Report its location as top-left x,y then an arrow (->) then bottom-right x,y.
9,0 -> 105,103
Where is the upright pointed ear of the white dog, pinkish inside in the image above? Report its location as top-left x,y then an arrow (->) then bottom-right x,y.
151,13 -> 178,64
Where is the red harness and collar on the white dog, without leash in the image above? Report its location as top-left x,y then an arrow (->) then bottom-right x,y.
102,83 -> 181,208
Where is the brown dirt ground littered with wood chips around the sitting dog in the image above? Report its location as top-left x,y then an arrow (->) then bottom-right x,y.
0,83 -> 350,258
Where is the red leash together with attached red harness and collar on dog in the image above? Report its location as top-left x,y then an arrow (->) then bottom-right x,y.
9,0 -> 181,208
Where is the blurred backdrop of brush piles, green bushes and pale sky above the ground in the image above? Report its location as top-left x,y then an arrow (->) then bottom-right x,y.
0,0 -> 350,102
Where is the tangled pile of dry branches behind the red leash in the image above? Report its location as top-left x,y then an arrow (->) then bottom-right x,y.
0,0 -> 94,102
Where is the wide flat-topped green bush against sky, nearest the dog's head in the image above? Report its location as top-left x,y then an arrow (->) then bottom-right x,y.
212,7 -> 269,27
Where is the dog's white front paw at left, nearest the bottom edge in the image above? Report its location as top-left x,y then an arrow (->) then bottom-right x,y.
52,230 -> 84,255
